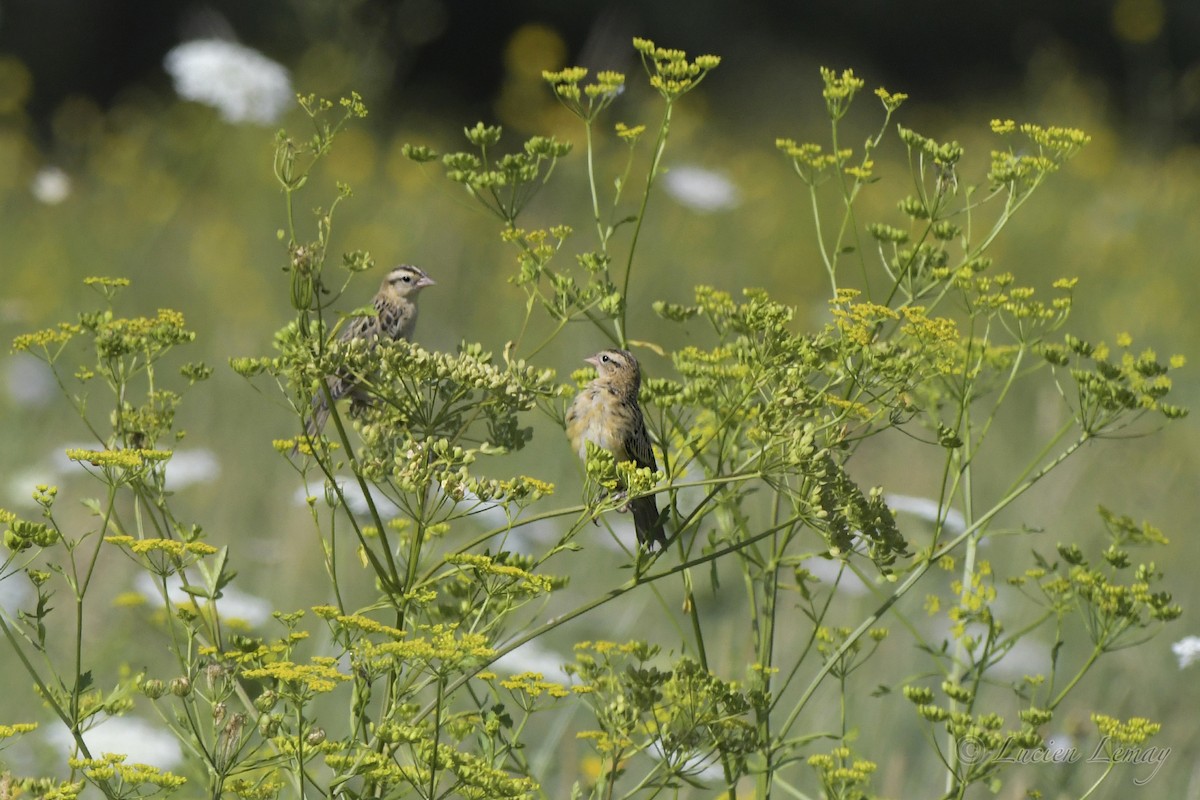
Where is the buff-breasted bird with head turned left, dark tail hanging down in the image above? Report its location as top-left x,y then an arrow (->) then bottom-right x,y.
566,350 -> 667,549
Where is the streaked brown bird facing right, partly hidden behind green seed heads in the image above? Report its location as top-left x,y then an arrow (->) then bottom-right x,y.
293,264 -> 437,452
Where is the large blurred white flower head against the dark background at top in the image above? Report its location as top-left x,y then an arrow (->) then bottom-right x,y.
163,38 -> 294,125
